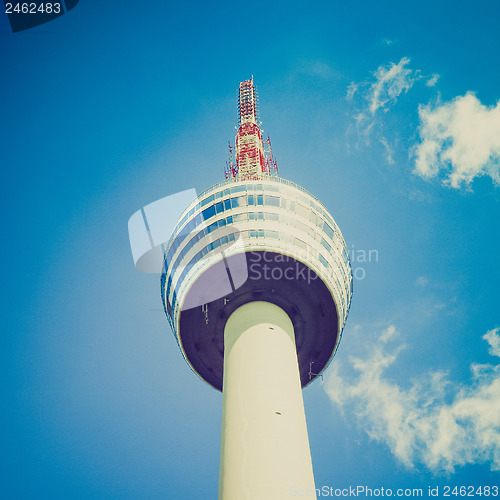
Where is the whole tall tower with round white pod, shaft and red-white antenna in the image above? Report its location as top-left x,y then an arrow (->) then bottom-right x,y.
161,77 -> 352,500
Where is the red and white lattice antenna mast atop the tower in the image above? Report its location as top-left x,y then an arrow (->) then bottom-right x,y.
225,77 -> 278,180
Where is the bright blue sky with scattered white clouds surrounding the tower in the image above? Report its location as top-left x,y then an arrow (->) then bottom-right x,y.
0,0 -> 500,499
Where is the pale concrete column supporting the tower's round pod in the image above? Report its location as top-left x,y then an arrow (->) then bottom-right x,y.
219,302 -> 316,500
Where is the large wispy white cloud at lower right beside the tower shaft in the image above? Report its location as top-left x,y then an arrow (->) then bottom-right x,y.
325,326 -> 500,472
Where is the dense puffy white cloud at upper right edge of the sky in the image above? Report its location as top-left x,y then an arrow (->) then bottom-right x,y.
414,92 -> 500,189
